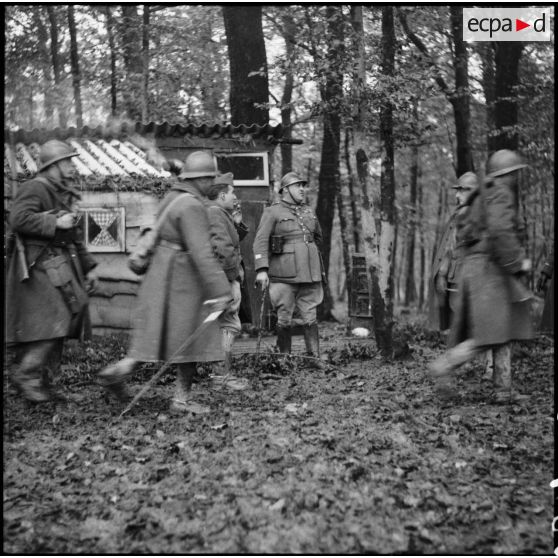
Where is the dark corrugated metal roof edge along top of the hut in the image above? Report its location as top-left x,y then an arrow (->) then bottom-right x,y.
4,121 -> 283,145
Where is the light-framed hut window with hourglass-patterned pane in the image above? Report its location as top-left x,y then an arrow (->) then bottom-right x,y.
82,207 -> 126,252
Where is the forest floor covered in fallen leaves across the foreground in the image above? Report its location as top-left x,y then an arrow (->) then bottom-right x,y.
4,326 -> 554,554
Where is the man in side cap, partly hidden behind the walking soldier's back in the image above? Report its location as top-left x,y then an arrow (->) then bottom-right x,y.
207,172 -> 248,373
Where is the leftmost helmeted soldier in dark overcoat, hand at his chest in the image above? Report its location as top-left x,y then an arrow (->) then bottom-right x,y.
6,140 -> 97,403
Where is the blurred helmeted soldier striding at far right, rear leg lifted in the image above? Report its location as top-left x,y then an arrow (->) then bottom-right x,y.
430,149 -> 533,403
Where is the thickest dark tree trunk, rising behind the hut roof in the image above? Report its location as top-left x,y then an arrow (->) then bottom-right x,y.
223,4 -> 269,126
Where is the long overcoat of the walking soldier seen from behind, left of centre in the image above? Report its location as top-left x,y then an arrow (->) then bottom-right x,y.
128,181 -> 231,363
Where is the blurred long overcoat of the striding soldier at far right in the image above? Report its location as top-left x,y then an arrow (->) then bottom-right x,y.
448,185 -> 533,346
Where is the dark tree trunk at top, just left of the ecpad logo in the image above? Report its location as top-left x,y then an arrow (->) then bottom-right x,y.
450,6 -> 475,177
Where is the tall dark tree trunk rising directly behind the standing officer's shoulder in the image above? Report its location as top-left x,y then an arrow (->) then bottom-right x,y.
316,5 -> 344,320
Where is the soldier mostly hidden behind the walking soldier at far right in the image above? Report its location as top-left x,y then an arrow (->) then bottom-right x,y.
428,172 -> 478,331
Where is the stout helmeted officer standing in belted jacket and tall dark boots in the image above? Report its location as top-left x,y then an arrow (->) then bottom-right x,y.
254,172 -> 323,364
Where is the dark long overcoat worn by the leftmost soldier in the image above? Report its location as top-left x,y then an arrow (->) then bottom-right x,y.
6,174 -> 97,344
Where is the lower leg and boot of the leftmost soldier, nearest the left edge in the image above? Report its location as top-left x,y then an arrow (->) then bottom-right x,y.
13,338 -> 63,403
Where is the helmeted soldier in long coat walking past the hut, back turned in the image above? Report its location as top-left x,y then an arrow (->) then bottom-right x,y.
98,151 -> 232,413
